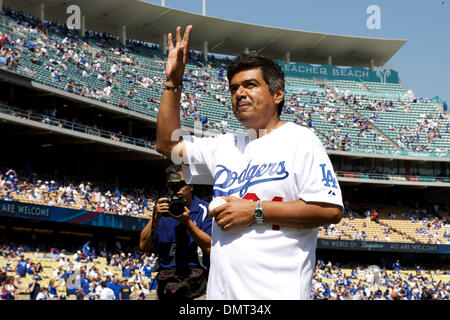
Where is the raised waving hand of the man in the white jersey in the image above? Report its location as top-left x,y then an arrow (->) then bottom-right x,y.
166,25 -> 192,87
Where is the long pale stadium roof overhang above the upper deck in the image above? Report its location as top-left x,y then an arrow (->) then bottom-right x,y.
3,0 -> 406,67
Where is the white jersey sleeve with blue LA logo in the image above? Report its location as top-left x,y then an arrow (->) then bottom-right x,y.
295,133 -> 344,208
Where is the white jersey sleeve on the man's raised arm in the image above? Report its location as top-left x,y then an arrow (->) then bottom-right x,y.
182,135 -> 217,185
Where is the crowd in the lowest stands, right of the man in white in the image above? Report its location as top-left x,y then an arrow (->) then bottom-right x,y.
312,260 -> 450,300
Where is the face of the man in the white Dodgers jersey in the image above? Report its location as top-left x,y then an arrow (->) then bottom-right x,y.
230,68 -> 284,129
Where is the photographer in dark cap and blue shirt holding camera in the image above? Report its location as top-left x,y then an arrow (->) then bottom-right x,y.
139,165 -> 211,300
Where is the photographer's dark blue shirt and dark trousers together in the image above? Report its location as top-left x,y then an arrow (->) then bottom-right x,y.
154,196 -> 212,300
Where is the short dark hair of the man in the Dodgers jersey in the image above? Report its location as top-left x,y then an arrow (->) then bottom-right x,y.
227,53 -> 284,116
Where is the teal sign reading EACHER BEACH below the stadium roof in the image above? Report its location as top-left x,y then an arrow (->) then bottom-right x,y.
277,60 -> 399,83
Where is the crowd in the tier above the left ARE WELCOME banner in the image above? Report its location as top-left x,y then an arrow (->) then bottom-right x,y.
0,168 -> 161,217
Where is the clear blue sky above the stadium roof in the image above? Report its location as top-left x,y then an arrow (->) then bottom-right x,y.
145,0 -> 450,102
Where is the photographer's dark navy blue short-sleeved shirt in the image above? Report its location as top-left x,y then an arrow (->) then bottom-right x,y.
155,196 -> 212,274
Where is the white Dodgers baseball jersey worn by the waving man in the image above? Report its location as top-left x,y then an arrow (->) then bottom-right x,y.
183,123 -> 343,300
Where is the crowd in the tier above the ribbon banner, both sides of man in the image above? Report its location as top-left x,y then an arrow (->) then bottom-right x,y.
0,162 -> 450,244
